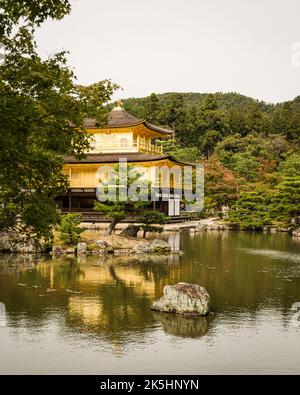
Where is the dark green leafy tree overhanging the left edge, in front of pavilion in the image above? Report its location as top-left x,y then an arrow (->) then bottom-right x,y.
0,0 -> 117,238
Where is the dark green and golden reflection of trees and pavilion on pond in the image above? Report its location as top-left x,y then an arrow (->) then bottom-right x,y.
0,232 -> 300,372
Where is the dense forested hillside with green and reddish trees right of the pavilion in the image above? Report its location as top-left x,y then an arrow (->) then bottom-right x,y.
124,93 -> 300,230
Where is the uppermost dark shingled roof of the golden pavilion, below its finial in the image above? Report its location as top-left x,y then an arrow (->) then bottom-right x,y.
84,105 -> 174,135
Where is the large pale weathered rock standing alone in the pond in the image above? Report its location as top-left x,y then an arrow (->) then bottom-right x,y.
151,283 -> 210,316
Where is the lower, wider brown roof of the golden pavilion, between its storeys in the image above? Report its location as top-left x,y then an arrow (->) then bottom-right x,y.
64,152 -> 195,165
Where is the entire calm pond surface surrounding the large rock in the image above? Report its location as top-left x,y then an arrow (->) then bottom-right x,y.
0,232 -> 300,374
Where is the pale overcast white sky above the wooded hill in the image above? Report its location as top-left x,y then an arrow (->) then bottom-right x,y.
36,0 -> 300,102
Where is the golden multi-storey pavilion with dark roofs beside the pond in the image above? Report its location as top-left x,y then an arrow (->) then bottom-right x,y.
58,103 -> 196,221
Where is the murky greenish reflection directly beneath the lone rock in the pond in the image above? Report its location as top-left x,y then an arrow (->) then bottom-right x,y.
154,313 -> 209,338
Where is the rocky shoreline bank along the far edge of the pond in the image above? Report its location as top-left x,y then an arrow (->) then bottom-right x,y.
0,218 -> 300,256
